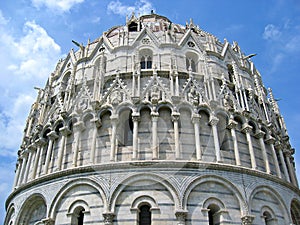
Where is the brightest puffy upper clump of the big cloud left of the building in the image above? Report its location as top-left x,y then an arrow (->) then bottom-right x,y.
4,21 -> 61,79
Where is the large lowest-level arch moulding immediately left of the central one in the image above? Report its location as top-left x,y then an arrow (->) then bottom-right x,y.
49,178 -> 107,218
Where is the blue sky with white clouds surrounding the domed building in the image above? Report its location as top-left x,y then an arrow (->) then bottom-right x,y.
0,0 -> 300,221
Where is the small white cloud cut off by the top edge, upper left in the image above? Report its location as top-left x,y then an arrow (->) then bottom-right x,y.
32,0 -> 84,12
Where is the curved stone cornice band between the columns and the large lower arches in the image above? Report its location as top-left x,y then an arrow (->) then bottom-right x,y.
5,160 -> 300,208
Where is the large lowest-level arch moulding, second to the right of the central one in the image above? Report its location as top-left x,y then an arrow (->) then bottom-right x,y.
247,185 -> 290,221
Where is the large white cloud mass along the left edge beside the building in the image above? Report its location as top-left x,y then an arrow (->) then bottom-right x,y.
0,11 -> 61,157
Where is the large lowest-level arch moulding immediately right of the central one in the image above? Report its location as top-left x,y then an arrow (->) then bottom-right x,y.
182,175 -> 245,214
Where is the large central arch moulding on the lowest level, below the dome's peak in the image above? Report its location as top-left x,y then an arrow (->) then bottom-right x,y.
109,173 -> 180,212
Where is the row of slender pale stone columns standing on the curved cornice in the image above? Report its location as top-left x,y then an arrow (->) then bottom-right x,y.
14,108 -> 298,188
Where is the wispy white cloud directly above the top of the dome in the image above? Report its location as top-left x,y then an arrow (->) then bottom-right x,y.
107,0 -> 154,16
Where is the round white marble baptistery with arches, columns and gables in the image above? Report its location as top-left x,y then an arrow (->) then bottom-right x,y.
4,13 -> 300,225
